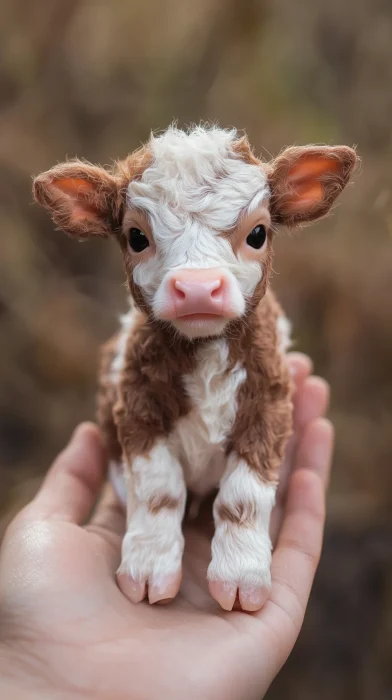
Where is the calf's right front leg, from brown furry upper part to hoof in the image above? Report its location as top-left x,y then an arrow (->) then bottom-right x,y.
208,363 -> 292,611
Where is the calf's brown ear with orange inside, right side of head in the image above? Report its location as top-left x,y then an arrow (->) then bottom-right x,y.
269,146 -> 358,226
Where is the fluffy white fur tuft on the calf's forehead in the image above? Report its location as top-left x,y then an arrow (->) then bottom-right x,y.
128,126 -> 269,235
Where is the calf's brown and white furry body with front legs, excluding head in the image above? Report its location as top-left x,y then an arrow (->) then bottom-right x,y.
98,292 -> 291,609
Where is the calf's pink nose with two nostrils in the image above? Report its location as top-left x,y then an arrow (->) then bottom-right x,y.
171,269 -> 224,318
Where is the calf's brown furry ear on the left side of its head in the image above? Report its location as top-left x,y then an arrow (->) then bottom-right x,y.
33,160 -> 120,238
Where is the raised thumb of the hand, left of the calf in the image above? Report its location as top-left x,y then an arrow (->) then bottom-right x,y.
29,423 -> 105,523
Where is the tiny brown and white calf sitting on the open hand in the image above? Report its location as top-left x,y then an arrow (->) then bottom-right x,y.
34,127 -> 356,611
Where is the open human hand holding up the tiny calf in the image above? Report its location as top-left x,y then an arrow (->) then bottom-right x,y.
0,353 -> 333,700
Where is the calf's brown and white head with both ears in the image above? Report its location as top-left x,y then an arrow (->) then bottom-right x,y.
34,127 -> 356,338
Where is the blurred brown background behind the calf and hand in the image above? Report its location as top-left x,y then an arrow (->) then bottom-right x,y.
0,0 -> 392,700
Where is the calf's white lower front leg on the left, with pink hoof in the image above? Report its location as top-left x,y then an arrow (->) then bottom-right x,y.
117,438 -> 186,603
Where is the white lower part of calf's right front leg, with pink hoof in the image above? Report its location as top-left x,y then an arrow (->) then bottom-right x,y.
208,452 -> 276,611
